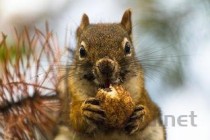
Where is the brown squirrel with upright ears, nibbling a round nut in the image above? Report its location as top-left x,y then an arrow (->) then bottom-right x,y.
55,9 -> 166,140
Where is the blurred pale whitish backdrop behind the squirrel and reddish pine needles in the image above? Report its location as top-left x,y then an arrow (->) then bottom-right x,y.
0,0 -> 210,140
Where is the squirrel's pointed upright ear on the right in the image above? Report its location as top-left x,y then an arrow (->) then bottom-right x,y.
121,9 -> 132,35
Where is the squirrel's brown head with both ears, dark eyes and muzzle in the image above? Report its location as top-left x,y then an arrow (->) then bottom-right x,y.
75,10 -> 139,87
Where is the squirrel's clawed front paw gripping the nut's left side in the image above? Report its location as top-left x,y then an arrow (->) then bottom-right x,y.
81,98 -> 106,131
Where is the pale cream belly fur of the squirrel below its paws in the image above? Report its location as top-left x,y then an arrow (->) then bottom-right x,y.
55,120 -> 165,140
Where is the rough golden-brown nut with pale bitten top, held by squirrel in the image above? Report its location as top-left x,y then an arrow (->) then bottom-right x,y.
96,85 -> 135,128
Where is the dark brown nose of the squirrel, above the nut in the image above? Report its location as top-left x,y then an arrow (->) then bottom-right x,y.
97,59 -> 115,77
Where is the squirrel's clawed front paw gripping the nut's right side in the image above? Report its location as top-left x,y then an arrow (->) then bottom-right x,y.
125,105 -> 145,134
